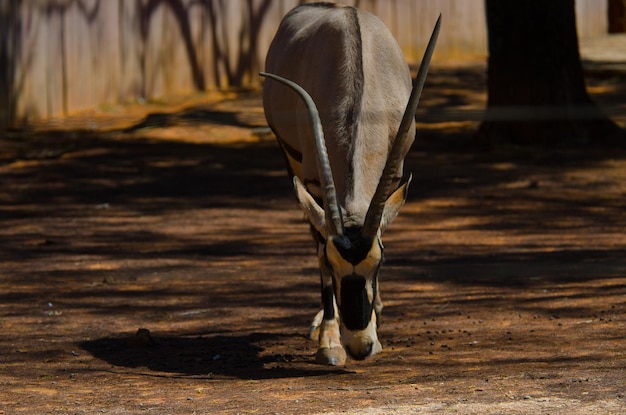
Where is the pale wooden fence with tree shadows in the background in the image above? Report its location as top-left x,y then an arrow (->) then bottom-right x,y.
0,0 -> 607,128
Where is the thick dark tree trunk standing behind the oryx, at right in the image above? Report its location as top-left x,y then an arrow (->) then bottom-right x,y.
475,0 -> 624,146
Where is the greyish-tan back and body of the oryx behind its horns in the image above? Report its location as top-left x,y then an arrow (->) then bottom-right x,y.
263,4 -> 413,216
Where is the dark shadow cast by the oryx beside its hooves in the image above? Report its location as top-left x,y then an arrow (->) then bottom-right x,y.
79,333 -> 349,379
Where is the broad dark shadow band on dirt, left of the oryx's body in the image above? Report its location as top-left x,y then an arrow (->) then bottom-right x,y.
0,134 -> 290,219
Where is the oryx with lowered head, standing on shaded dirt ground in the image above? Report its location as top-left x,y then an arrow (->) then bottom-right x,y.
261,3 -> 441,365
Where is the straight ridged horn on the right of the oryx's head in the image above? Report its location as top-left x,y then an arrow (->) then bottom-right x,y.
362,14 -> 441,239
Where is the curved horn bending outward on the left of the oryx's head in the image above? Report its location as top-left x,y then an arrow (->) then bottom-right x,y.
259,72 -> 344,235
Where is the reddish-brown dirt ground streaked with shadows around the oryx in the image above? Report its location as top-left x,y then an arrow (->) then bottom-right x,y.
0,67 -> 626,415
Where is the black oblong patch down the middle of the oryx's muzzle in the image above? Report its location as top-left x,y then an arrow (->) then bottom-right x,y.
340,275 -> 376,330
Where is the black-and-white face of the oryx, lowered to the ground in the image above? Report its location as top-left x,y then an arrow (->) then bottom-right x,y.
324,232 -> 383,359
